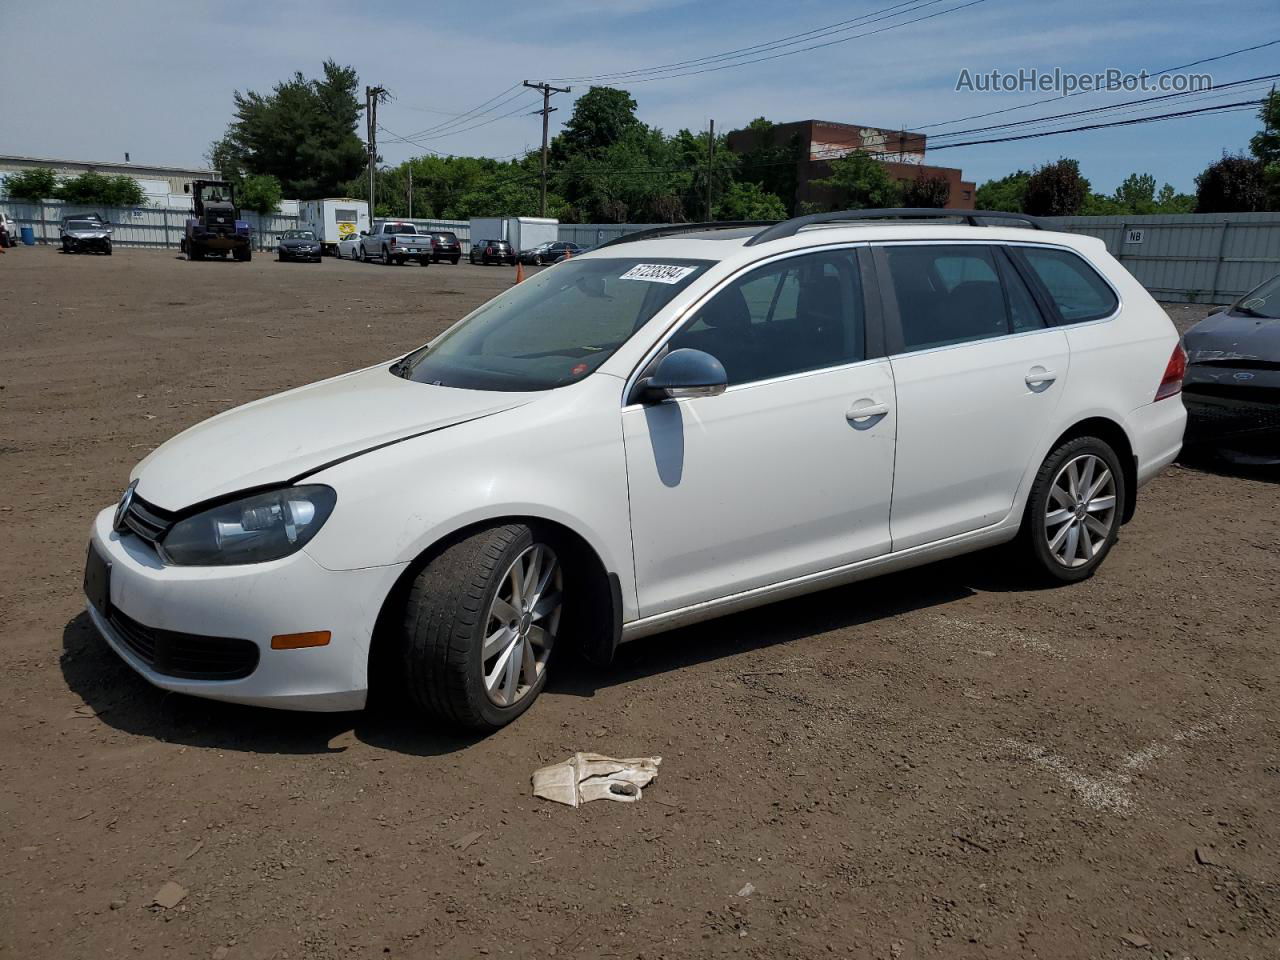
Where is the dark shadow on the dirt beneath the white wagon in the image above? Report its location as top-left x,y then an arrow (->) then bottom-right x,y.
60,554 -> 1027,756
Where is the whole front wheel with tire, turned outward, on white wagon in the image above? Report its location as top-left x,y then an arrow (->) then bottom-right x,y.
402,524 -> 564,731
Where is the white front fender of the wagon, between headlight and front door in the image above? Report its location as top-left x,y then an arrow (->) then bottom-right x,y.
306,374 -> 636,620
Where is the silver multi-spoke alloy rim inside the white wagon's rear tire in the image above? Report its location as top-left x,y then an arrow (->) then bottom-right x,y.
1044,453 -> 1116,567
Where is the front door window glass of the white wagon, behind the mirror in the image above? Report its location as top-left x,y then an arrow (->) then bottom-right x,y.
671,251 -> 865,384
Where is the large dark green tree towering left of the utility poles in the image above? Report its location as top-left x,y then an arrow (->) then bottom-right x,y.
211,60 -> 367,200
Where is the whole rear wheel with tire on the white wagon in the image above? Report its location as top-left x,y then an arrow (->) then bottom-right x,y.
1020,436 -> 1126,584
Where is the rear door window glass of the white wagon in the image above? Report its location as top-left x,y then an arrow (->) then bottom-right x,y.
883,244 -> 1042,351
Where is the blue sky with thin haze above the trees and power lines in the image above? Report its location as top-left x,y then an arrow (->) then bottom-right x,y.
0,0 -> 1280,191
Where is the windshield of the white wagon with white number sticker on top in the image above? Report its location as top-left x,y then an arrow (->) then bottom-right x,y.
393,257 -> 712,390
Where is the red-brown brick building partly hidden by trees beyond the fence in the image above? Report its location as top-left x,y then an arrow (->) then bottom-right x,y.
728,120 -> 975,210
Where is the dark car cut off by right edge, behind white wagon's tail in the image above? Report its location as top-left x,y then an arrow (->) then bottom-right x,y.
1183,276 -> 1280,463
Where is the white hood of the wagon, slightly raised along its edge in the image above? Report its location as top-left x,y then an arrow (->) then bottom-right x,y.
132,364 -> 532,511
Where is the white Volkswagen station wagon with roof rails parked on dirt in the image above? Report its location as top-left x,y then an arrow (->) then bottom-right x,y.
84,210 -> 1185,728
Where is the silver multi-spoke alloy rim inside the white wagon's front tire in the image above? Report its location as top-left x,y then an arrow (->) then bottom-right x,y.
480,543 -> 564,707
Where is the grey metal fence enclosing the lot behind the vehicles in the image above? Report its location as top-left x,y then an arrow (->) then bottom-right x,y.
0,201 -> 1280,303
